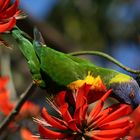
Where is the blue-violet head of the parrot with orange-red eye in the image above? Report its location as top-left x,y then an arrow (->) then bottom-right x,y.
110,75 -> 140,109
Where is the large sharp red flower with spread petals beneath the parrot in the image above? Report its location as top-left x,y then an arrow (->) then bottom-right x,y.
36,85 -> 134,140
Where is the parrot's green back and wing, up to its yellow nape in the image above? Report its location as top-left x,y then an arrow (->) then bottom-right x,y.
41,47 -> 130,86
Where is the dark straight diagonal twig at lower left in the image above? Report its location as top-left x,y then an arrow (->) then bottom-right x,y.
0,83 -> 36,134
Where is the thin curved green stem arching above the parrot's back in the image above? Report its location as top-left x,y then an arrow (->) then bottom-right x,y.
69,51 -> 140,76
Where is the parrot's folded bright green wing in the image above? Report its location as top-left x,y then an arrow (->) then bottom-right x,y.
40,47 -> 84,86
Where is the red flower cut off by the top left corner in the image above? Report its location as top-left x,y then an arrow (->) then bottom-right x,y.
0,0 -> 20,33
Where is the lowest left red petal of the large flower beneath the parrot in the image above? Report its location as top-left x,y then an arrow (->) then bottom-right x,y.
38,124 -> 68,139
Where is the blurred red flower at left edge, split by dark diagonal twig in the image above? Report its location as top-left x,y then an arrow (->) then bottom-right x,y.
0,77 -> 40,120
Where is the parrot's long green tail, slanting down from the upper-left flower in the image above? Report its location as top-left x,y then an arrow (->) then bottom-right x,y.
12,28 -> 44,87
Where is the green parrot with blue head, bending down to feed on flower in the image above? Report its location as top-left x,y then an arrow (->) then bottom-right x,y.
11,28 -> 140,109
